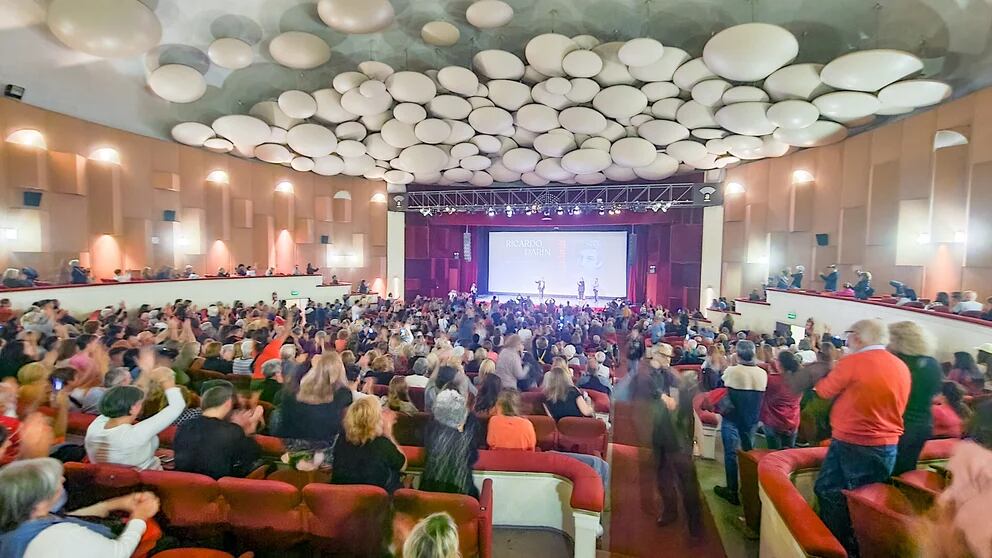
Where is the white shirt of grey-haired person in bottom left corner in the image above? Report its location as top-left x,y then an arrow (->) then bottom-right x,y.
24,519 -> 147,558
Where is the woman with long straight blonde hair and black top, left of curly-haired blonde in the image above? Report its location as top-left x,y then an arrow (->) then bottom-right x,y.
276,352 -> 353,445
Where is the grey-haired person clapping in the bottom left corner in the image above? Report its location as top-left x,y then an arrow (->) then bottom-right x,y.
0,457 -> 159,558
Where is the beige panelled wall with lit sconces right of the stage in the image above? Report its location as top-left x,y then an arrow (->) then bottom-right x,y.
722,89 -> 992,297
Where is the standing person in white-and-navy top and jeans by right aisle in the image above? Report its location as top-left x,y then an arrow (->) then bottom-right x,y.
713,340 -> 768,506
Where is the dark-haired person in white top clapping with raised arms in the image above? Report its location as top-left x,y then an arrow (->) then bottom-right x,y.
86,367 -> 186,470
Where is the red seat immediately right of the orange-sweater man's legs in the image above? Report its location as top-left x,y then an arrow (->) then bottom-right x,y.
844,483 -> 920,558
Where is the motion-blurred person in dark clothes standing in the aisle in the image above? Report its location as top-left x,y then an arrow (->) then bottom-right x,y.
633,360 -> 702,540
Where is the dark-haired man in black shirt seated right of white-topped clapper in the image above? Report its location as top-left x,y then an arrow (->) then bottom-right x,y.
173,383 -> 262,479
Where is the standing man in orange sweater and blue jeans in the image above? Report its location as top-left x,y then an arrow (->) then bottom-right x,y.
814,320 -> 910,556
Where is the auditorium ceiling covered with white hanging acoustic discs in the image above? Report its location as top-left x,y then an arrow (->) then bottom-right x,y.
0,0 -> 992,186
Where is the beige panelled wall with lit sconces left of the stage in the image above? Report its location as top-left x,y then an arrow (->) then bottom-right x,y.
0,99 -> 386,283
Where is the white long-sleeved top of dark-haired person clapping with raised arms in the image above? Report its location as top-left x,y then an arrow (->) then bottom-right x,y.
86,387 -> 186,470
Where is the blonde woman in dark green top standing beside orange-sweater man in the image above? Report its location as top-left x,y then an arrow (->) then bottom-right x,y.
889,321 -> 944,475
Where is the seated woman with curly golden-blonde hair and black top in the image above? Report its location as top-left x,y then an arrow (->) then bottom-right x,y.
331,397 -> 406,493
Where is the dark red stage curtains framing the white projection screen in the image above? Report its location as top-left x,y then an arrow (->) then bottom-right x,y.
405,209 -> 703,309
